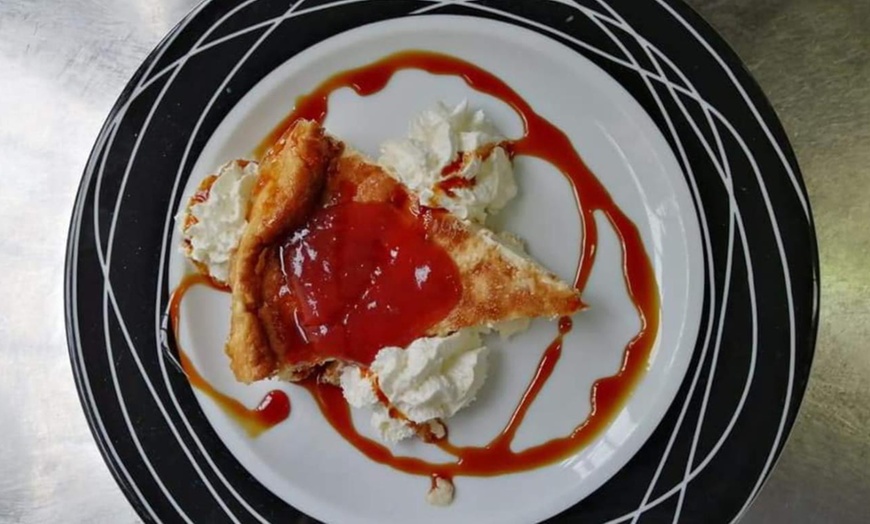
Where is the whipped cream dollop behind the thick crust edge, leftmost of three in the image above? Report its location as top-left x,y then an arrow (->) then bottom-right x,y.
176,160 -> 259,283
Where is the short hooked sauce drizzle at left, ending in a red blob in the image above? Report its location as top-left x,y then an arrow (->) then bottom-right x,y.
169,273 -> 290,437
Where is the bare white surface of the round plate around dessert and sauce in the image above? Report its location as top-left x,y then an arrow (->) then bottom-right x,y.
170,16 -> 703,523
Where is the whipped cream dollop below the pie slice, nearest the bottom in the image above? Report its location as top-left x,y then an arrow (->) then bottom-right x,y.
341,328 -> 489,442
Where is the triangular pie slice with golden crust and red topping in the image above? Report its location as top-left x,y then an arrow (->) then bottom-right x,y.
226,121 -> 582,383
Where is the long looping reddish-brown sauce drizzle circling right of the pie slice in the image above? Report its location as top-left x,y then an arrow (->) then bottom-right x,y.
266,51 -> 659,478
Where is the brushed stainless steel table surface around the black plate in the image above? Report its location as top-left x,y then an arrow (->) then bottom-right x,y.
0,0 -> 870,523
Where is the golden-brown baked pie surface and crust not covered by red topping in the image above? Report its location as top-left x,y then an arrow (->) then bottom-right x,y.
226,121 -> 582,382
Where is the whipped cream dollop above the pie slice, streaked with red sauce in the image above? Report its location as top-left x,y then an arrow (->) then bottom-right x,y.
378,101 -> 517,223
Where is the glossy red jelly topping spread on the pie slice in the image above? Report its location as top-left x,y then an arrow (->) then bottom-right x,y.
282,199 -> 462,366
